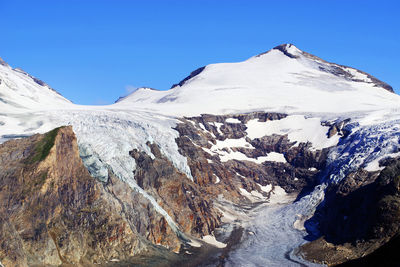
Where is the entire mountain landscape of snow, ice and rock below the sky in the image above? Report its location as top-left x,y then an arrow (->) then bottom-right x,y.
0,44 -> 400,267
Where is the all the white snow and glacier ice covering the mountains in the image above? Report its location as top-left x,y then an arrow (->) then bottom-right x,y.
0,45 -> 400,266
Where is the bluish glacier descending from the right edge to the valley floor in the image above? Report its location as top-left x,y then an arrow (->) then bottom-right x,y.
223,114 -> 400,266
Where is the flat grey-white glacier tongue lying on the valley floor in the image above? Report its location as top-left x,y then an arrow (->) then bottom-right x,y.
226,186 -> 323,267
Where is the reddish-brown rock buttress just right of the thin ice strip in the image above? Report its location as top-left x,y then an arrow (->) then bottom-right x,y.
130,143 -> 220,237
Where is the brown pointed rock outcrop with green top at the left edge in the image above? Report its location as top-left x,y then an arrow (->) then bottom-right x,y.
0,127 -> 180,266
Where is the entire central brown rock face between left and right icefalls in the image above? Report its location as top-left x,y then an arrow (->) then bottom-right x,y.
130,112 -> 338,245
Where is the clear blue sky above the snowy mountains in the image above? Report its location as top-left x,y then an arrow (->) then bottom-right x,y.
0,0 -> 400,104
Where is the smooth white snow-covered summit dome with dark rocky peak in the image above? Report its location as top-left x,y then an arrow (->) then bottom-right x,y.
116,44 -> 400,115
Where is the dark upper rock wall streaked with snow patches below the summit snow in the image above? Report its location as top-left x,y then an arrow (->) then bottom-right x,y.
176,112 -> 334,200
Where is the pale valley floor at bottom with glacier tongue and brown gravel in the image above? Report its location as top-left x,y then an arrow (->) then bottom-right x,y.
123,193 -> 321,267
